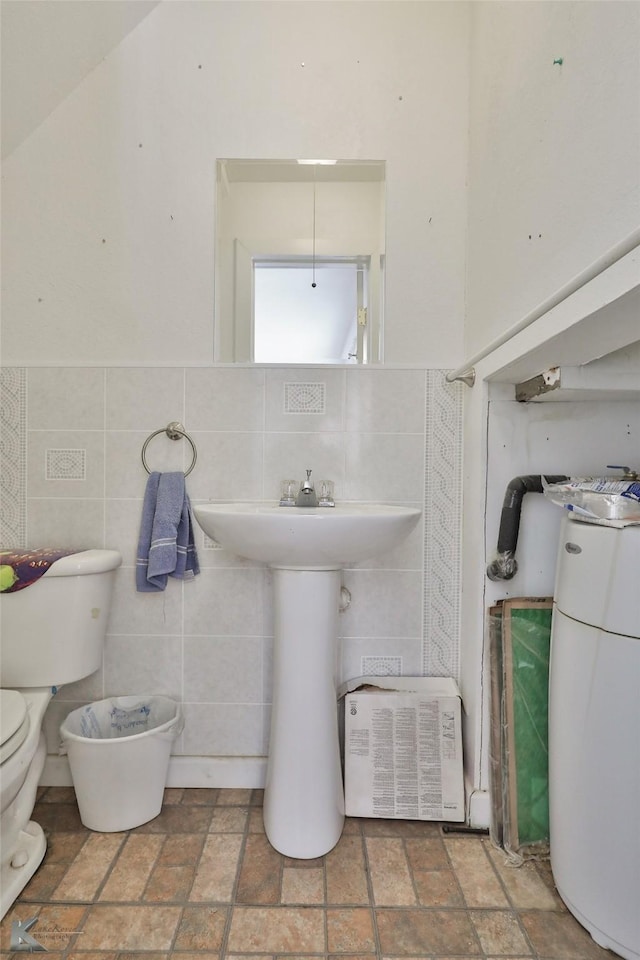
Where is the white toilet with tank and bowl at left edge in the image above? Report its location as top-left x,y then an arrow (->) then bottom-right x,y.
0,550 -> 122,918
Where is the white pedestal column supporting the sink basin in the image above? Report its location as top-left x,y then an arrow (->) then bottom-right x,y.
264,567 -> 344,860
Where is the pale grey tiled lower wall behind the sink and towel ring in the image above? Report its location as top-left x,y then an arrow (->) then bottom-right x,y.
3,367 -> 461,756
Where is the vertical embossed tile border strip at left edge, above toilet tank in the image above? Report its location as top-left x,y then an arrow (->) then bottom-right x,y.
0,367 -> 27,548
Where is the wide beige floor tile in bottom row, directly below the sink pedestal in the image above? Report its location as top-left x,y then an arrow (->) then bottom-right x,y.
228,907 -> 325,960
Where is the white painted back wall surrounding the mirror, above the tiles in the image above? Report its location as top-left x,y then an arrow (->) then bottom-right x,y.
2,0 -> 468,367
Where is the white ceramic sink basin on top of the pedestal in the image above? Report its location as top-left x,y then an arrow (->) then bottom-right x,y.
193,502 -> 420,570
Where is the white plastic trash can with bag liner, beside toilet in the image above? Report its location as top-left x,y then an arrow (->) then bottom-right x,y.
60,696 -> 184,833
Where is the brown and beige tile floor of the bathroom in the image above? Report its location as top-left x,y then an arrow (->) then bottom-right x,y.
0,787 -> 613,960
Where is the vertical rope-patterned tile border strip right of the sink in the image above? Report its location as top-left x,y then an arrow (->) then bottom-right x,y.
423,370 -> 462,679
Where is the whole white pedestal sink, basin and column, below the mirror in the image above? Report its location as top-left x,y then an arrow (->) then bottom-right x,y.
193,502 -> 420,859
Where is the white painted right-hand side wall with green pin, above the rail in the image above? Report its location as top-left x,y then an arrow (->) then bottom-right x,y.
465,0 -> 640,356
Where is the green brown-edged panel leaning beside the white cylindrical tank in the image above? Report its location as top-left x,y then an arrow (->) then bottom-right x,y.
492,597 -> 553,857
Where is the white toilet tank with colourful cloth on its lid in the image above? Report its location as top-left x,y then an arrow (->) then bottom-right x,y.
0,550 -> 122,687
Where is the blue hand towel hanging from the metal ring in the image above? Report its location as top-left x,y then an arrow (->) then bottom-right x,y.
136,472 -> 200,593
